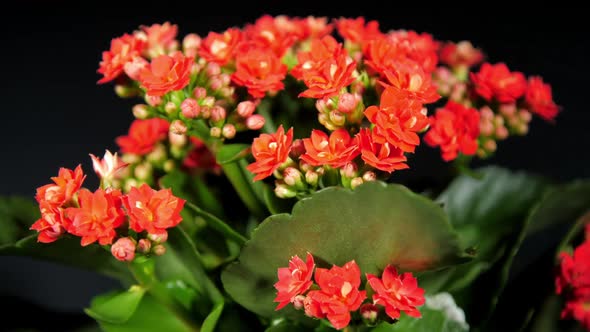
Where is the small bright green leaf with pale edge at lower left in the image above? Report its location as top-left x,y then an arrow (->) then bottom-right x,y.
84,286 -> 145,324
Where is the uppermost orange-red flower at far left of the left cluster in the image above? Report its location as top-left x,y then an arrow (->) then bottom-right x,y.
35,165 -> 86,208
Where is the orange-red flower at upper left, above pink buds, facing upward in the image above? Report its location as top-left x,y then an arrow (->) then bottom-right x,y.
139,52 -> 193,97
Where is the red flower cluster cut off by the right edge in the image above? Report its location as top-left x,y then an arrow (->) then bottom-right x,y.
555,225 -> 590,329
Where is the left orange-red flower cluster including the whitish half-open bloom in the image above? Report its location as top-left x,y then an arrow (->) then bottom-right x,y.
31,151 -> 185,261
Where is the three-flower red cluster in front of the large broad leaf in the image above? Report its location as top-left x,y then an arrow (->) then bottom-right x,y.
274,253 -> 425,329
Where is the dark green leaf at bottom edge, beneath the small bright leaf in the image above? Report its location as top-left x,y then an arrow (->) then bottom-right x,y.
99,294 -> 193,332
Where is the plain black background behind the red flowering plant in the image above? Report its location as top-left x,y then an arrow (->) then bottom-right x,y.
0,1 -> 590,331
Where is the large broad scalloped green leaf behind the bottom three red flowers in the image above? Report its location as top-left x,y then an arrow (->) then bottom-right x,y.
221,182 -> 469,319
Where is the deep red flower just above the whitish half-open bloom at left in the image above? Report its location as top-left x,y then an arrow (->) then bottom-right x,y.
116,118 -> 170,155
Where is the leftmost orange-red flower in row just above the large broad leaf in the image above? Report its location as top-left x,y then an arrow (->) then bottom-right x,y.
247,125 -> 293,181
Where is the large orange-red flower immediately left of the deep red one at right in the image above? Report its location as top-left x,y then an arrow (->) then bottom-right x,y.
365,86 -> 428,152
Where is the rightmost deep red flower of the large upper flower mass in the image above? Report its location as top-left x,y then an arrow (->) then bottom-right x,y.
524,76 -> 559,121
